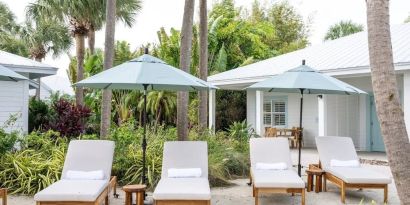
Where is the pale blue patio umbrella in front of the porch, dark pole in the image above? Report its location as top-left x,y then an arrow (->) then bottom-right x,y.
247,60 -> 366,176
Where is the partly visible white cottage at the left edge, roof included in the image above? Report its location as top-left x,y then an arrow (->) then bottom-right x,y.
0,51 -> 57,133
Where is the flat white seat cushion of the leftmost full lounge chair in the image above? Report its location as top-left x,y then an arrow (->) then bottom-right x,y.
34,179 -> 108,201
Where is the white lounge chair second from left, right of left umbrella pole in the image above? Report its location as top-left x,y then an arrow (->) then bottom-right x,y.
153,141 -> 211,205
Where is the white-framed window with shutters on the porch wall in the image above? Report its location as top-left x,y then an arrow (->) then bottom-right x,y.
263,99 -> 287,127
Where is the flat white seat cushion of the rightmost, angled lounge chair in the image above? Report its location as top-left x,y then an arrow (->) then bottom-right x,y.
325,167 -> 392,184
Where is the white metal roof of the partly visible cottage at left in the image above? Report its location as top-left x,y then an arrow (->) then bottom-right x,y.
0,50 -> 58,79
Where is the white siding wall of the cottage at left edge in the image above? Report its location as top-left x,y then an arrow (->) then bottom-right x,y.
0,81 -> 29,133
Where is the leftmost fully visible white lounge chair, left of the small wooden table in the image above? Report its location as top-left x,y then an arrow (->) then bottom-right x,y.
34,140 -> 115,205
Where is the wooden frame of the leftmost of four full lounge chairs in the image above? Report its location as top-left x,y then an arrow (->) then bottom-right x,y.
36,176 -> 118,205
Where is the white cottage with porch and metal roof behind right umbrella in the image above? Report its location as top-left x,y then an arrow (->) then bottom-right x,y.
208,24 -> 410,151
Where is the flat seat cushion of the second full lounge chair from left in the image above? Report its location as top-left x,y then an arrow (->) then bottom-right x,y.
153,178 -> 211,200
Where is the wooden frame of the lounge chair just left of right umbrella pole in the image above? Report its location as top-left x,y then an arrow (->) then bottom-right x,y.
250,172 -> 306,205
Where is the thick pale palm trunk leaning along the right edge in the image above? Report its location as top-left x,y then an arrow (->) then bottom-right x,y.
367,0 -> 410,204
